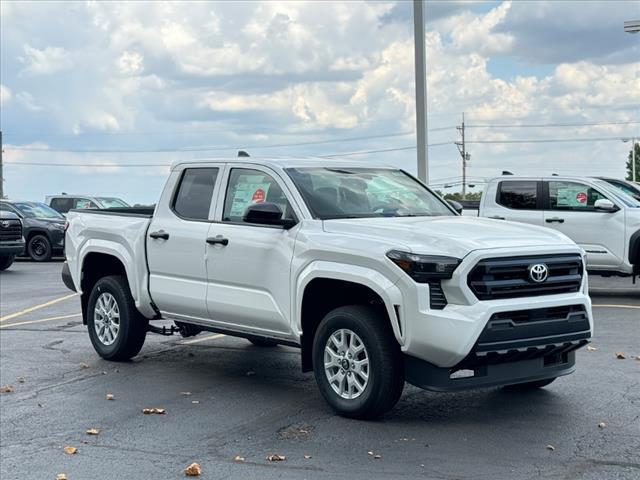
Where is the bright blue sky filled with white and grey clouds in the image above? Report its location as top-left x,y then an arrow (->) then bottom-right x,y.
0,0 -> 640,204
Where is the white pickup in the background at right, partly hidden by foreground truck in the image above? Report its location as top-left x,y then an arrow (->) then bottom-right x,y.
479,175 -> 640,280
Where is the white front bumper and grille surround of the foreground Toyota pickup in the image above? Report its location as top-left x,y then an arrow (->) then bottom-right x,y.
395,246 -> 593,369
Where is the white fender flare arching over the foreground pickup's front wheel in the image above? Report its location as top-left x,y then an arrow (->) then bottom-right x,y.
293,260 -> 404,346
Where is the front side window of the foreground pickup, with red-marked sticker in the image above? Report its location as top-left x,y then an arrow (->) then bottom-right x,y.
222,168 -> 295,223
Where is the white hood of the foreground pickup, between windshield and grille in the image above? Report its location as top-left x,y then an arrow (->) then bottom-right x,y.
324,216 -> 575,258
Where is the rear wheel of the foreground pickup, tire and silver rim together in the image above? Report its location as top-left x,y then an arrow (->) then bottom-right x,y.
87,275 -> 149,360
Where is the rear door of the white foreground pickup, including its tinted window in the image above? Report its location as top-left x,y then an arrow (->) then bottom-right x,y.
146,164 -> 222,320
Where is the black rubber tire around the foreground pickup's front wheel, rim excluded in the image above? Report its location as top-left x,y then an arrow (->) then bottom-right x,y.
313,305 -> 404,419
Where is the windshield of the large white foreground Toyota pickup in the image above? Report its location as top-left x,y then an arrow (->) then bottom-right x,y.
286,167 -> 455,220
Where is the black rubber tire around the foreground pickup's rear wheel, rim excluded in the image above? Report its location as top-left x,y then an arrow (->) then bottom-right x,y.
87,275 -> 149,361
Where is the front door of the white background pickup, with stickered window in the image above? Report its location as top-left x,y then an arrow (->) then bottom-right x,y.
544,180 -> 625,269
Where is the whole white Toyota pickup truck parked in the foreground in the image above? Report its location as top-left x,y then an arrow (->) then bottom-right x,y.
62,158 -> 593,418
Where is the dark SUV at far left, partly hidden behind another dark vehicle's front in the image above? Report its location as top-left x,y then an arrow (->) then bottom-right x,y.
0,200 -> 65,262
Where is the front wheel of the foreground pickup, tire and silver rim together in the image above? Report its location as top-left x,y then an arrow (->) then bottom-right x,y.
313,305 -> 404,419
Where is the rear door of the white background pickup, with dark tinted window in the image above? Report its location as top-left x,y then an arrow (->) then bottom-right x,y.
482,179 -> 543,226
